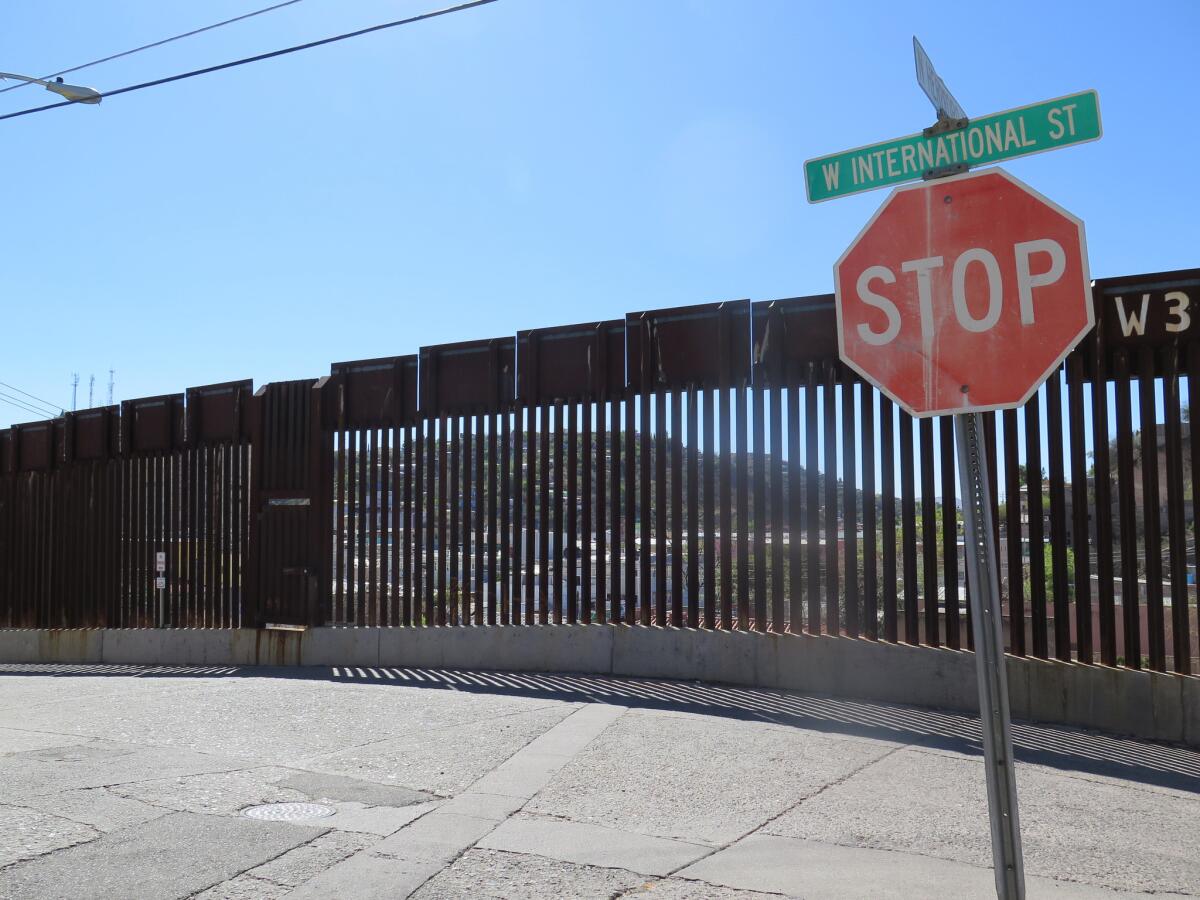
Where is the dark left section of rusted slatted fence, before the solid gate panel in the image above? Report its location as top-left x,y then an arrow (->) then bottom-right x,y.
0,382 -> 251,628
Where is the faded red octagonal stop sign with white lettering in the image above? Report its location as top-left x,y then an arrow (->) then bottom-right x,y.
834,168 -> 1093,416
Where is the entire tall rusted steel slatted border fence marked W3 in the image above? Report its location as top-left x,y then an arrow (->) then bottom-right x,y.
0,269 -> 1200,672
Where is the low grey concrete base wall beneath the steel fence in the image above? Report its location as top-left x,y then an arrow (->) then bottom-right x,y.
0,625 -> 1200,749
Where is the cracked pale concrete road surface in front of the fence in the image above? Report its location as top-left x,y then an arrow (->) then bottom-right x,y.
0,665 -> 1200,900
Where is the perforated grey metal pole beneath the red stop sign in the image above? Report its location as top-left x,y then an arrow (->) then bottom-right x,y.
954,413 -> 1025,900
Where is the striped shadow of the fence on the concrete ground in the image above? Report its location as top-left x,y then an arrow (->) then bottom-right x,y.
0,664 -> 1200,793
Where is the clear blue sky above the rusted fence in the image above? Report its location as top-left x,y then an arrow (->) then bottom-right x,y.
0,0 -> 1200,425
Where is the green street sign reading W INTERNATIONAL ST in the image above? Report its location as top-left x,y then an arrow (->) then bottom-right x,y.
804,90 -> 1100,203
